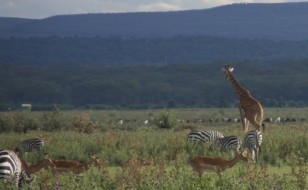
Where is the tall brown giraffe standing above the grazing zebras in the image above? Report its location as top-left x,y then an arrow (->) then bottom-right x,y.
225,65 -> 263,132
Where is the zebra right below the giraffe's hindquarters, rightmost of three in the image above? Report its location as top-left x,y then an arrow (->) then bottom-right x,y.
243,130 -> 262,161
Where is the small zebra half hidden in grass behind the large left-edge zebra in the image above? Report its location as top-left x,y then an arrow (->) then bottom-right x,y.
15,138 -> 44,153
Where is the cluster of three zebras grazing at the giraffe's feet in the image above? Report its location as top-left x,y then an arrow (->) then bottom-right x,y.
187,130 -> 262,161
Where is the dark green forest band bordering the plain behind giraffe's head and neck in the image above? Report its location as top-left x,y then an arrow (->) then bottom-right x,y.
0,59 -> 308,111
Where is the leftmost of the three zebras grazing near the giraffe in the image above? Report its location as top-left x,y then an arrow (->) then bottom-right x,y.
187,130 -> 224,143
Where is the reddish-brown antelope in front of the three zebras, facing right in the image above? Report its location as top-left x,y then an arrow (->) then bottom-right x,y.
190,151 -> 248,178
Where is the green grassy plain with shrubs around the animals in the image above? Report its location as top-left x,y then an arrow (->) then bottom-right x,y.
0,108 -> 308,189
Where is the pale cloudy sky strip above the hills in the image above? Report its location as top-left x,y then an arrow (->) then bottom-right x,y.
0,0 -> 308,18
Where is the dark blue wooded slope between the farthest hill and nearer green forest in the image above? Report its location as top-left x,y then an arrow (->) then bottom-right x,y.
0,36 -> 308,65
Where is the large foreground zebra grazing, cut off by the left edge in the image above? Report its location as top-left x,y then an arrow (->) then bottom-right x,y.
0,150 -> 33,188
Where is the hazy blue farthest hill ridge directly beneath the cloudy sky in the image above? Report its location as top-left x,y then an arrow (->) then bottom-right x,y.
0,2 -> 308,40
